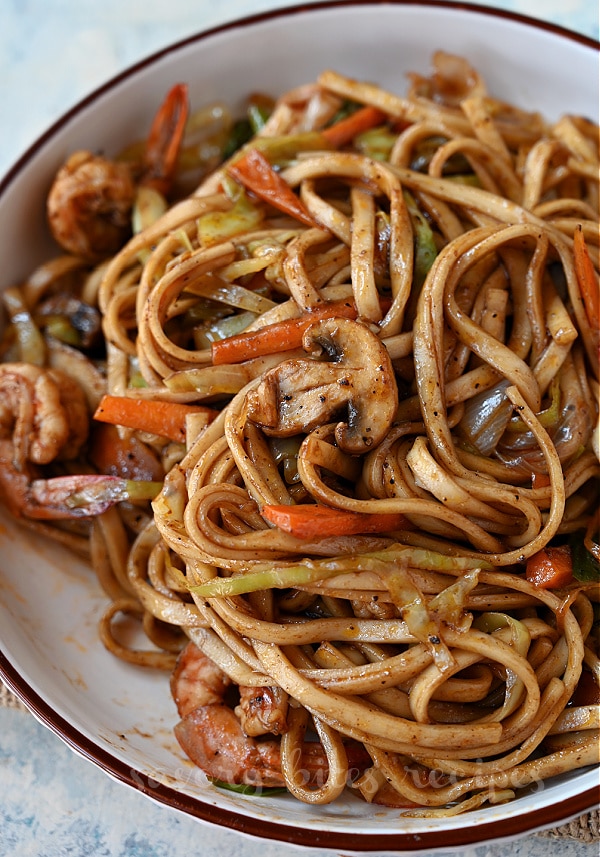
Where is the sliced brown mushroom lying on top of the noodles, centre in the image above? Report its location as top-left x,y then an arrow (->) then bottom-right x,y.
247,310 -> 398,455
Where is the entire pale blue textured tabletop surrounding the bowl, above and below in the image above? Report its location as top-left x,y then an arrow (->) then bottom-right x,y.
0,0 -> 598,857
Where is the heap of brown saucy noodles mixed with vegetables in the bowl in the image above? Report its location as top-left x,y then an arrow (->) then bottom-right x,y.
4,53 -> 600,814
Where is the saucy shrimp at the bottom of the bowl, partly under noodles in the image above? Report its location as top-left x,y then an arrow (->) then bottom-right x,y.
171,642 -> 371,788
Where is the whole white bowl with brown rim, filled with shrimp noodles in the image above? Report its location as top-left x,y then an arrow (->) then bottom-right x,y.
0,2 -> 600,854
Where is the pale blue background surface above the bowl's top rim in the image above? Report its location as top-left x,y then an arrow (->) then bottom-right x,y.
0,0 -> 599,175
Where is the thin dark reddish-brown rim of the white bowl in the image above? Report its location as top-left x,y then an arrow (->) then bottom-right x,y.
0,0 -> 600,853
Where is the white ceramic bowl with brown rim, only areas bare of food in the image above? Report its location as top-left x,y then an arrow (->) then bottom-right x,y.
0,2 -> 598,855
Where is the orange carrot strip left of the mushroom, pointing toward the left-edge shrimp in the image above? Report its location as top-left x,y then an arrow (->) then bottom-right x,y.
94,395 -> 218,443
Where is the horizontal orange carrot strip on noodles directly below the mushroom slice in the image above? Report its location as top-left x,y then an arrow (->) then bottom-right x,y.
261,504 -> 406,539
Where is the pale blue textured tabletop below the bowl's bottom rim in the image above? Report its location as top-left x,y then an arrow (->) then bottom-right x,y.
0,708 -> 598,857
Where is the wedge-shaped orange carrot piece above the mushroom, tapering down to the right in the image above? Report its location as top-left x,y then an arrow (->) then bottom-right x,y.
227,149 -> 318,226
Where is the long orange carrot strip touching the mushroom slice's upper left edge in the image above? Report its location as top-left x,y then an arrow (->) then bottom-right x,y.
211,300 -> 358,366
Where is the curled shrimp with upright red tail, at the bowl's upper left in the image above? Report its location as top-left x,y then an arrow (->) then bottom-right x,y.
47,84 -> 188,262
